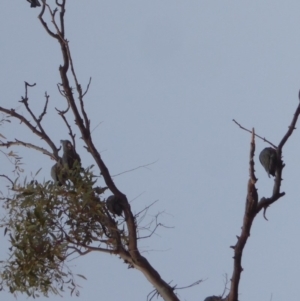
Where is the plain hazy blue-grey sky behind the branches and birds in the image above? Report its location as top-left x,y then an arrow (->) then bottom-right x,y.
0,0 -> 300,301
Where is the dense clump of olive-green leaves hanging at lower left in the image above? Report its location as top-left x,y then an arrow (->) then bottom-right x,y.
0,169 -> 125,297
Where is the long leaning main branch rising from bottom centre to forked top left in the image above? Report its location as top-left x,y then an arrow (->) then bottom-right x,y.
39,1 -> 183,301
